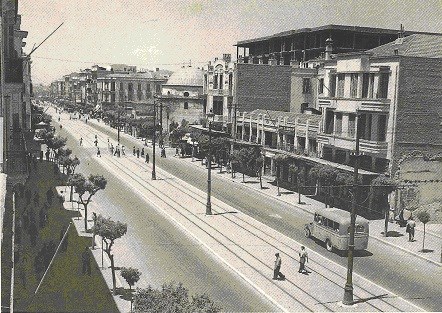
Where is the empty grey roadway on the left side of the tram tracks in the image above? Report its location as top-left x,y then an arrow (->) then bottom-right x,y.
57,114 -> 276,311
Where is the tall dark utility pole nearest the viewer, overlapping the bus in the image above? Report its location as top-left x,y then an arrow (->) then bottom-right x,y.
342,114 -> 359,305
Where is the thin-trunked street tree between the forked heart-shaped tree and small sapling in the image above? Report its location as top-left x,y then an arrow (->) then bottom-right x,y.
92,214 -> 127,295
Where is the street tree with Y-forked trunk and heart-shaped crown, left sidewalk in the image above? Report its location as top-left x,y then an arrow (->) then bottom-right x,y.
71,174 -> 107,231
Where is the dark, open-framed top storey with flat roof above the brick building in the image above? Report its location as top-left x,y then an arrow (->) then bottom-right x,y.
236,25 -> 438,65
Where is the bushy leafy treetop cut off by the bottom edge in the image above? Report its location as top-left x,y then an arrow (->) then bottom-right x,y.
134,283 -> 221,313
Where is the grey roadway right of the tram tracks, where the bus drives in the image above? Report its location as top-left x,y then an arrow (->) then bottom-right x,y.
78,116 -> 442,311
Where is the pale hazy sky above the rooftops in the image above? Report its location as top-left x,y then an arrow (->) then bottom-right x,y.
19,0 -> 442,84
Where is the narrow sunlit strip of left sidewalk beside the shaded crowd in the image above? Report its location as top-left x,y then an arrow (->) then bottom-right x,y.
56,186 -> 130,313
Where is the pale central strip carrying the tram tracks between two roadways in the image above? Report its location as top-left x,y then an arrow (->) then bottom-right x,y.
53,114 -> 422,312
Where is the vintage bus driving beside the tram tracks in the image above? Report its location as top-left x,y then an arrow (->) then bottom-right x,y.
304,208 -> 369,251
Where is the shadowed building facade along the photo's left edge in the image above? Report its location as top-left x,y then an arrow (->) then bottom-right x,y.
0,0 -> 33,174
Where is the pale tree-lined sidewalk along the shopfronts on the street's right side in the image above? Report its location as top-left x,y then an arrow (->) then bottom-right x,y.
88,116 -> 442,266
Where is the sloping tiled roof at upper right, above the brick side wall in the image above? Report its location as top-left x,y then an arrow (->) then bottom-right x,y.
367,34 -> 442,58
